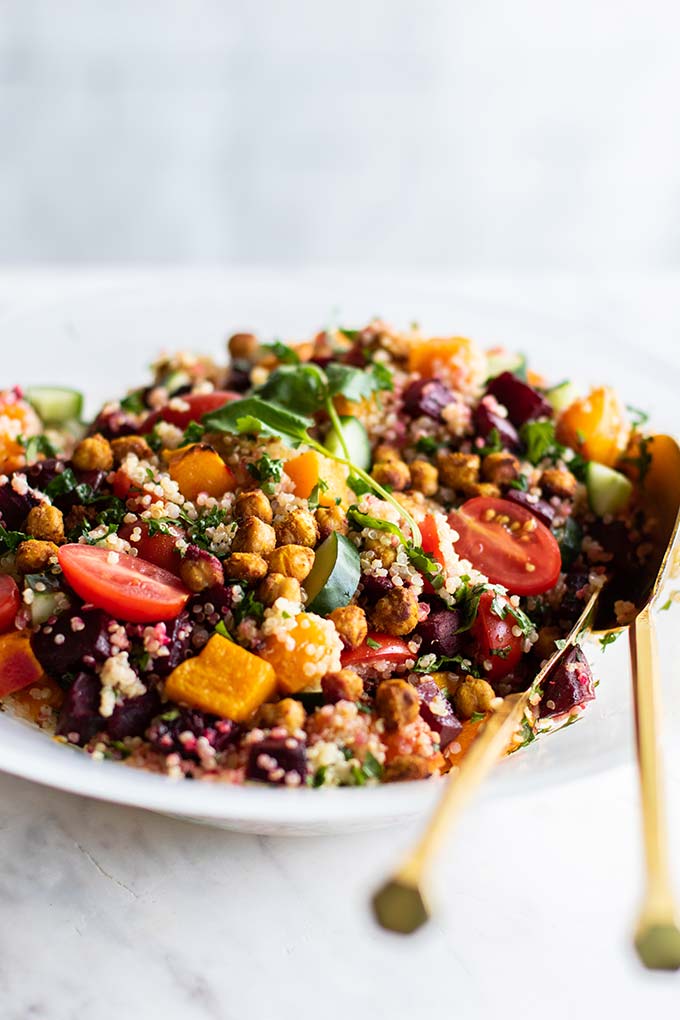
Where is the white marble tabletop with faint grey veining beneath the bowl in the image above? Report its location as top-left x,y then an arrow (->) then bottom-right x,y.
0,271 -> 680,1020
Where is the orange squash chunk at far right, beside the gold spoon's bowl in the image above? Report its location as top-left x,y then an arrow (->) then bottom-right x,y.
557,387 -> 630,467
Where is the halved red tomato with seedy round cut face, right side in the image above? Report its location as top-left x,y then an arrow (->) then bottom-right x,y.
449,496 -> 562,595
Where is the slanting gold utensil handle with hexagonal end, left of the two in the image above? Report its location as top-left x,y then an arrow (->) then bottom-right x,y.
373,691 -> 530,934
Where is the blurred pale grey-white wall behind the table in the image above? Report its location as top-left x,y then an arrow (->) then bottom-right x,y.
0,0 -> 680,270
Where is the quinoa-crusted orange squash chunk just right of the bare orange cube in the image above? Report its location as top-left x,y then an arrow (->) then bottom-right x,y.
260,613 -> 343,694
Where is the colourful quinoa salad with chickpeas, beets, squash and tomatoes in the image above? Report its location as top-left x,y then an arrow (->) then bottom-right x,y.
0,320 -> 653,787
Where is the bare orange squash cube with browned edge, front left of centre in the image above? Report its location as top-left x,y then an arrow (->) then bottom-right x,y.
165,634 -> 276,722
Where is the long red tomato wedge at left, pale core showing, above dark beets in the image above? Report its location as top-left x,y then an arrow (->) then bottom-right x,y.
59,545 -> 190,623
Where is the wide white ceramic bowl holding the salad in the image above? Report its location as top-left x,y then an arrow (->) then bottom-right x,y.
0,272 -> 680,834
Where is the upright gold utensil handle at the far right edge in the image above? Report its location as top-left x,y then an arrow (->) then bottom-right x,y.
630,606 -> 680,970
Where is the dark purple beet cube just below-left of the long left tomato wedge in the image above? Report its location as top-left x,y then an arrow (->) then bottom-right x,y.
31,608 -> 113,680
